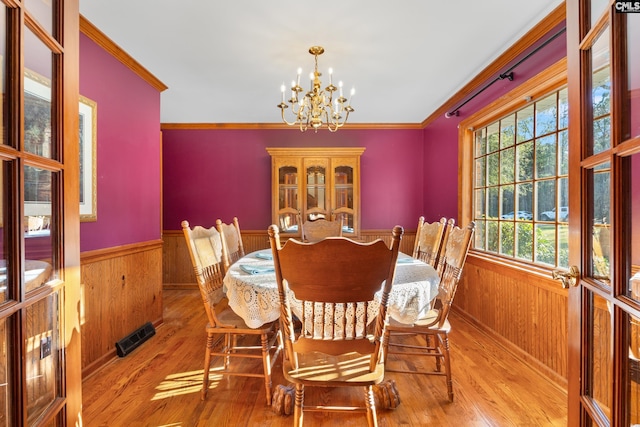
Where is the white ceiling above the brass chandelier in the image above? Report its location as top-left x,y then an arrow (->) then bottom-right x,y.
80,0 -> 562,123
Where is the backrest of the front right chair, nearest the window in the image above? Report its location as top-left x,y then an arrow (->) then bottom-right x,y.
432,220 -> 476,327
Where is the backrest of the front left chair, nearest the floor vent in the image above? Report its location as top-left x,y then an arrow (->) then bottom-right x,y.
182,221 -> 226,326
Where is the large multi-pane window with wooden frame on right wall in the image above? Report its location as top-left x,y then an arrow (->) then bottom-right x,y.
461,59 -> 569,267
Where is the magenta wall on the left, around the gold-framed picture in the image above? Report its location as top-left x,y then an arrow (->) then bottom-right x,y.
80,34 -> 161,251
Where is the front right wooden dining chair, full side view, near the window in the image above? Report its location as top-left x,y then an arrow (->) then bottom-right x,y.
385,222 -> 475,401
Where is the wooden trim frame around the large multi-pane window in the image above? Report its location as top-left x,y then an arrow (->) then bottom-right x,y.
458,58 -> 567,274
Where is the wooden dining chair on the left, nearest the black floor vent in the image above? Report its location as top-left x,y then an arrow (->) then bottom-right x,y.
182,221 -> 282,405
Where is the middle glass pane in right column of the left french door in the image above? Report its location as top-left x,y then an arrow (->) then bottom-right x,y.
23,166 -> 55,292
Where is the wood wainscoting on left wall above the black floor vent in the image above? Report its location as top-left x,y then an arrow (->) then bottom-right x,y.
80,240 -> 162,376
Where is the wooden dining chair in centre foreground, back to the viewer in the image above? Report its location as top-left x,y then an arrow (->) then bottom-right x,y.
269,225 -> 404,426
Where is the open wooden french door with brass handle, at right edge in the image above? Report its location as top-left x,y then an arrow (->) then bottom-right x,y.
563,0 -> 640,427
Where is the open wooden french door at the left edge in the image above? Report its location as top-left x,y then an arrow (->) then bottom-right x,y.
0,0 -> 82,427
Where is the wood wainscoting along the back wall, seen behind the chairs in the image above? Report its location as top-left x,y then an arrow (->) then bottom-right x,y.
162,229 -> 416,289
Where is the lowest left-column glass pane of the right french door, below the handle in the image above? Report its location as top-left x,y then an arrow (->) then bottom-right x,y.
587,294 -> 613,422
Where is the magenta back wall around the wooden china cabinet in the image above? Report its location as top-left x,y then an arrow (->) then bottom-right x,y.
163,128 -> 424,230
